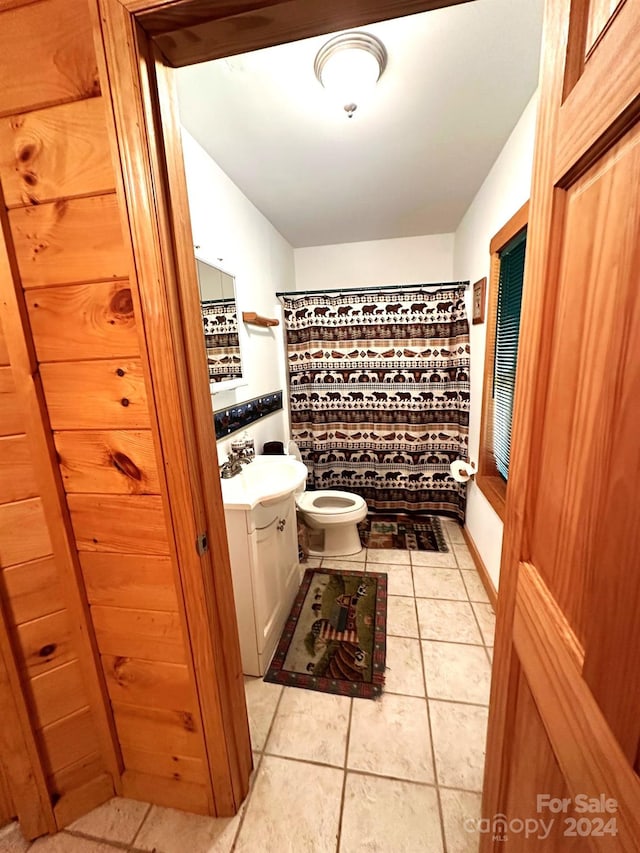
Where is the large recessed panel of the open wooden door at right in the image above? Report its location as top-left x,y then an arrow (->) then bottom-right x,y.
532,111 -> 640,740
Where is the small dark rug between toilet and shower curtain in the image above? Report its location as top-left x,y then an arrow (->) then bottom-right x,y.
358,513 -> 449,551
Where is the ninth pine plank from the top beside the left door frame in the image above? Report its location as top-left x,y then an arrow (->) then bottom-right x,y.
91,605 -> 186,663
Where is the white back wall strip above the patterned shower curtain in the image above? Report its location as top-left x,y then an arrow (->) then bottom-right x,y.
294,234 -> 454,290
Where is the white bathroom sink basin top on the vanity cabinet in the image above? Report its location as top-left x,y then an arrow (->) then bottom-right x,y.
220,456 -> 307,510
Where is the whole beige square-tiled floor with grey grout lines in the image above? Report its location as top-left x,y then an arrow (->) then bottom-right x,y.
0,521 -> 495,853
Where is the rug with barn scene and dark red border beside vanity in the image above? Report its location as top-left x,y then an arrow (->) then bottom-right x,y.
264,569 -> 387,699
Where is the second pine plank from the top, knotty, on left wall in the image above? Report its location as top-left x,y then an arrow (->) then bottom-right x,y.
0,98 -> 115,208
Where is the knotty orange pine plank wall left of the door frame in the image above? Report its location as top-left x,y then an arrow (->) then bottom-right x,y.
0,0 -> 213,823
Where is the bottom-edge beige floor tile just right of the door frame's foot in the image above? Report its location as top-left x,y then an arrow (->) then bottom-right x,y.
235,756 -> 344,853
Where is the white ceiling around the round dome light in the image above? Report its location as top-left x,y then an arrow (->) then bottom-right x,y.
177,0 -> 543,247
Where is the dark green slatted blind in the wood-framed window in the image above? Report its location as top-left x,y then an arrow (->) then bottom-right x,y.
493,228 -> 527,480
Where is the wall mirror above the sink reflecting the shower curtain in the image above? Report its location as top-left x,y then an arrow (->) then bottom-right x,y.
196,251 -> 242,393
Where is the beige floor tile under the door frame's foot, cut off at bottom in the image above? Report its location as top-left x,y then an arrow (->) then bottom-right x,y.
134,806 -> 243,853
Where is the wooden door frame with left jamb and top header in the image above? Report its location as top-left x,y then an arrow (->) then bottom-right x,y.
96,0 -> 476,816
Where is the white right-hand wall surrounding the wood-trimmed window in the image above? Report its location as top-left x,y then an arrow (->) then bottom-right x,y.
453,95 -> 537,587
